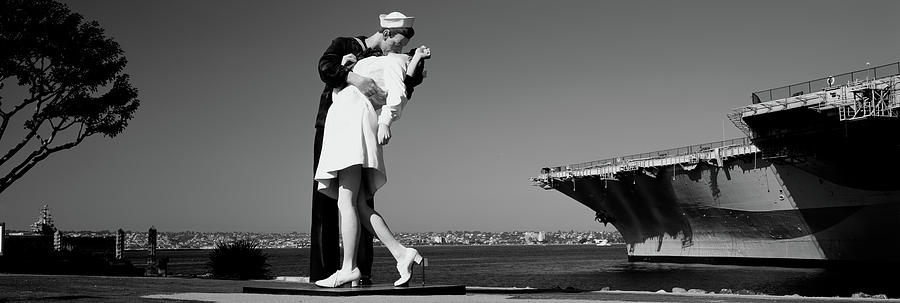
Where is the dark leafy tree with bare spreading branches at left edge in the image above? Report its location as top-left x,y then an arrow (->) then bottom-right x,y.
0,0 -> 140,193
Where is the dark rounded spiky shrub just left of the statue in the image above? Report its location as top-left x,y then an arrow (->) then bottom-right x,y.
208,240 -> 269,280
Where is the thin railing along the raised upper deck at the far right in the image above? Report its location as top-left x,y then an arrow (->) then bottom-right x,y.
750,62 -> 900,104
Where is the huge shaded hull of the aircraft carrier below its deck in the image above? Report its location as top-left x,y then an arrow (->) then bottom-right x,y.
552,147 -> 900,266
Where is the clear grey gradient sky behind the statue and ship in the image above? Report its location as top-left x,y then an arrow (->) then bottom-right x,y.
0,0 -> 900,232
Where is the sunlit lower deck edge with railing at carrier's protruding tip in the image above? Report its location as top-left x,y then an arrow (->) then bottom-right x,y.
532,137 -> 758,183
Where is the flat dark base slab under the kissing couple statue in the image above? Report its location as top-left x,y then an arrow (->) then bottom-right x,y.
244,284 -> 466,297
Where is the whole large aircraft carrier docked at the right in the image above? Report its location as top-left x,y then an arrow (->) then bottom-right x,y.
531,63 -> 900,266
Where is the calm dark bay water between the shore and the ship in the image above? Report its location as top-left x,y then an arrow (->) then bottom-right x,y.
126,245 -> 900,298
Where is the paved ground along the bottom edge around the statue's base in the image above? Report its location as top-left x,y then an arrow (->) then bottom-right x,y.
0,274 -> 900,303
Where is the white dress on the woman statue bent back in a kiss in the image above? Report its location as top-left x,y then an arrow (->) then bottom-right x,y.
315,53 -> 409,199
